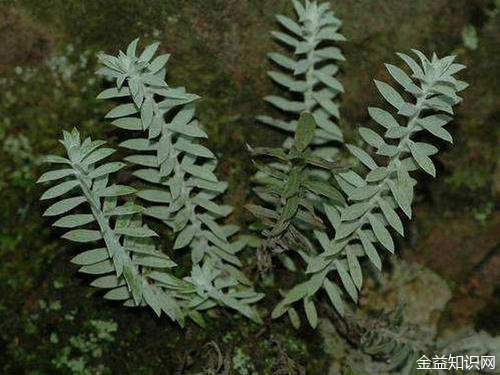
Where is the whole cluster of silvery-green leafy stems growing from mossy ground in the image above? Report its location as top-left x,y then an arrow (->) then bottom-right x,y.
38,6 -> 467,350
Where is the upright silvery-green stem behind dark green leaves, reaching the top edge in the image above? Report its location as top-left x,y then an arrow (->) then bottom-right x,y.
253,0 -> 345,271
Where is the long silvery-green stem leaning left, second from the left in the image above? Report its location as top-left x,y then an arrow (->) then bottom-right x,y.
98,40 -> 264,321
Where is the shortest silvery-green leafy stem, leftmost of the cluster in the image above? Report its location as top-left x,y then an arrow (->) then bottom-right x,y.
38,129 -> 196,325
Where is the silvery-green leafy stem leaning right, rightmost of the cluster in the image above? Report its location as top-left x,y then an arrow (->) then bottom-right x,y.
274,50 -> 467,326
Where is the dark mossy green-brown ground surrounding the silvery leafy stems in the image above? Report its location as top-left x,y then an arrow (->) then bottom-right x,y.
0,0 -> 500,374
